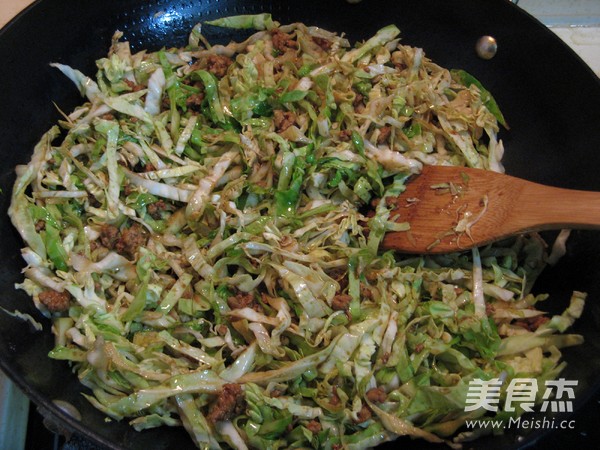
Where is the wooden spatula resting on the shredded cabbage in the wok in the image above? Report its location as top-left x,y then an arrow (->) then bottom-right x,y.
383,166 -> 600,253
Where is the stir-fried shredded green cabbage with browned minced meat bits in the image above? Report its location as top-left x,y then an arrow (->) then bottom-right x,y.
10,15 -> 585,449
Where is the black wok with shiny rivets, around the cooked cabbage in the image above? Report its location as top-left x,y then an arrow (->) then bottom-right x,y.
0,0 -> 600,449
